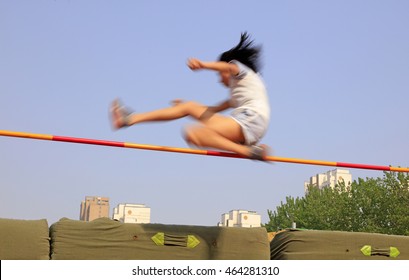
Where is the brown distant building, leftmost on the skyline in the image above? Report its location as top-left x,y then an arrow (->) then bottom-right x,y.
80,196 -> 109,221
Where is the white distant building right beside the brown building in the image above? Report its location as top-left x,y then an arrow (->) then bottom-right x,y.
112,203 -> 151,224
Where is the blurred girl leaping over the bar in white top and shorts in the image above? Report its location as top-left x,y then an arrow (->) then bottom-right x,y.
111,33 -> 270,160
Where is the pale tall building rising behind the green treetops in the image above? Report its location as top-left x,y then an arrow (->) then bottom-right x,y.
304,169 -> 352,192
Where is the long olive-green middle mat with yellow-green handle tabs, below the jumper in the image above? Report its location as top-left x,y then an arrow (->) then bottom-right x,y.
50,218 -> 270,260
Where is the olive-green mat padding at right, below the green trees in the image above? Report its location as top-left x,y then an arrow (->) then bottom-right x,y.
270,230 -> 409,260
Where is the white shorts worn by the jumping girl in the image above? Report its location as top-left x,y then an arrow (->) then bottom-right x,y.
231,109 -> 268,146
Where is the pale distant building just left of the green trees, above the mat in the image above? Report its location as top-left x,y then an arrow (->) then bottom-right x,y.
218,210 -> 261,227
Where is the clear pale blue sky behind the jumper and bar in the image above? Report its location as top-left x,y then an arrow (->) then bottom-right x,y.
0,0 -> 409,225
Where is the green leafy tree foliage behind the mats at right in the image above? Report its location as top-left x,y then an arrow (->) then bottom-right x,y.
264,172 -> 409,235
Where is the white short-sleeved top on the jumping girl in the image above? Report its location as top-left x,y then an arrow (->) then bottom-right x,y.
229,60 -> 270,123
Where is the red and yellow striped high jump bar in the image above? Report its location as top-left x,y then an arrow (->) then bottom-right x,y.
0,130 -> 409,172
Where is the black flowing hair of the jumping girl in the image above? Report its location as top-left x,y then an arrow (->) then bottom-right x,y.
219,32 -> 261,73
